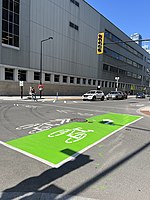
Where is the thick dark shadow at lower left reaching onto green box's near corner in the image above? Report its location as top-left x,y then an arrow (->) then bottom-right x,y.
1,149 -> 93,200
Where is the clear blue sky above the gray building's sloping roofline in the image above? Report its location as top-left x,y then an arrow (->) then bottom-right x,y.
86,0 -> 150,45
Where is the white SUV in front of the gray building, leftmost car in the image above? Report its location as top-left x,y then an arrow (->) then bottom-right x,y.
82,90 -> 105,101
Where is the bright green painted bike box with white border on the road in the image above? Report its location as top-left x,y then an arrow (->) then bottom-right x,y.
3,113 -> 141,167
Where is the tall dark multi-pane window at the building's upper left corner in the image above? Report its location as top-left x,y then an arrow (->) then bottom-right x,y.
2,0 -> 20,47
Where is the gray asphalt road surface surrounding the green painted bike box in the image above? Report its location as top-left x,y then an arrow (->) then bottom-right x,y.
0,98 -> 150,200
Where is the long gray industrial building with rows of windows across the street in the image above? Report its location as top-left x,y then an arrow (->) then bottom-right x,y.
0,0 -> 150,95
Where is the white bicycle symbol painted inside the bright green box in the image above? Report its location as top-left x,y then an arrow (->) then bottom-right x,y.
48,127 -> 94,143
